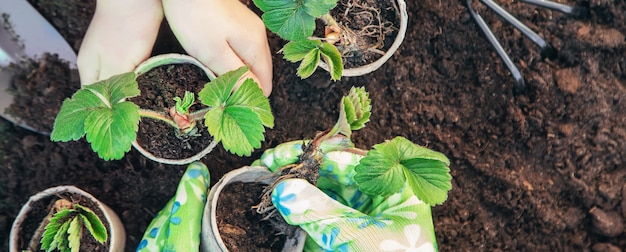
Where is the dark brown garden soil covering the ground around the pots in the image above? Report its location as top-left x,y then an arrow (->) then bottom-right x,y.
0,0 -> 626,251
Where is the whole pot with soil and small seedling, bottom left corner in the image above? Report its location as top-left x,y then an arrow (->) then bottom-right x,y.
9,186 -> 126,252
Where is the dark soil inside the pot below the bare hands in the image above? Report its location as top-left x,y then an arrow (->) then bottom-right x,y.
130,64 -> 213,159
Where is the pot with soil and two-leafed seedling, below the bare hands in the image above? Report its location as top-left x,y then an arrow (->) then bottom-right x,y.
50,54 -> 274,165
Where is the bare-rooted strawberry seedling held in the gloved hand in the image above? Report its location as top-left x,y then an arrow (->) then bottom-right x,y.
257,88 -> 452,222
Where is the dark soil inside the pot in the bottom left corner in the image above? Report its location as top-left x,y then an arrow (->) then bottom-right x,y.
18,190 -> 111,251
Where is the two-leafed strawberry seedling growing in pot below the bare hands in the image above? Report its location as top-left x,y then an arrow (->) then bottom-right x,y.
50,67 -> 274,160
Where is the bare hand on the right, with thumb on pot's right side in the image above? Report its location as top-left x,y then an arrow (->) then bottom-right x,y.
163,0 -> 272,96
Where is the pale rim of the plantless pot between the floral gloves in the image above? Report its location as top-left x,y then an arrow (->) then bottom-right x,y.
200,166 -> 306,252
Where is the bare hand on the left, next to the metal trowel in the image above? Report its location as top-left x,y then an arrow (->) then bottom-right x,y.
77,0 -> 163,85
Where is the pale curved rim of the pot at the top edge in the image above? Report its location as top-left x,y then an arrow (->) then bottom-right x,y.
319,0 -> 408,76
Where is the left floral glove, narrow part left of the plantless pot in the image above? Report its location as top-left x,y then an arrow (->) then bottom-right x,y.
137,162 -> 210,251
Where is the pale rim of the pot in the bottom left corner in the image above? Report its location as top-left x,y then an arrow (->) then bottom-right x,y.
9,186 -> 126,252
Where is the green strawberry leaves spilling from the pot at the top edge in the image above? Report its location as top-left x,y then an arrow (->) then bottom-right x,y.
253,0 -> 343,80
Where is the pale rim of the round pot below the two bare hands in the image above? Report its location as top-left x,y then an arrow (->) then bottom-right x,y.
132,53 -> 218,165
